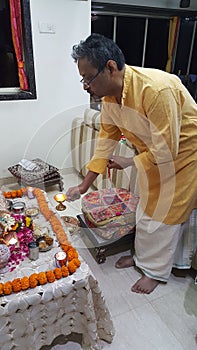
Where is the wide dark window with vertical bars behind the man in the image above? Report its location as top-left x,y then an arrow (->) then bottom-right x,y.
91,2 -> 197,74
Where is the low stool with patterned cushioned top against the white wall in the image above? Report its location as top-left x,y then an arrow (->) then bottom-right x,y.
8,158 -> 63,192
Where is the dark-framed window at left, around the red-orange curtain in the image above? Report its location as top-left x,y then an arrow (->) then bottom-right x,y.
0,0 -> 36,100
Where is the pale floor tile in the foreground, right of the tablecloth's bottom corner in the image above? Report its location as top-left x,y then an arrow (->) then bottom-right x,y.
103,304 -> 183,350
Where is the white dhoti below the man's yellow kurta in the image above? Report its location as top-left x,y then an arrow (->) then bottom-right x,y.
133,206 -> 197,282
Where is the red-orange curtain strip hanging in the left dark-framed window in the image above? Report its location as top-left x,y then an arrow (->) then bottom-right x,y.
10,0 -> 28,90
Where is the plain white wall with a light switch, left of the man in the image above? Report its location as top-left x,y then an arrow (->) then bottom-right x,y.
0,0 -> 91,178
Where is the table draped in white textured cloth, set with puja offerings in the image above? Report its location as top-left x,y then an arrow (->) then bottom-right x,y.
0,193 -> 114,350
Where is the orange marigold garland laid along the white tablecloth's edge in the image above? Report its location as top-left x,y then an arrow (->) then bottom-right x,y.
0,188 -> 81,296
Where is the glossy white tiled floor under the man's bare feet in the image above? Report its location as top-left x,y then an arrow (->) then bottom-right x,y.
3,174 -> 197,350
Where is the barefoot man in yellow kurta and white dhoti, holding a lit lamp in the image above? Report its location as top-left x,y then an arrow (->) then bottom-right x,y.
67,34 -> 197,294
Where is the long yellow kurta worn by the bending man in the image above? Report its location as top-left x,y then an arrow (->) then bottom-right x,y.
87,65 -> 197,224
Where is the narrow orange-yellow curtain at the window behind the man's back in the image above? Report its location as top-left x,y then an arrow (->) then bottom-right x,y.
166,16 -> 179,73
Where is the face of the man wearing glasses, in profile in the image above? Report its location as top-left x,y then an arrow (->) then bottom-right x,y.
78,58 -> 109,100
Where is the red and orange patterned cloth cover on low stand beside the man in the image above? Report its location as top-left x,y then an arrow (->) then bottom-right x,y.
82,188 -> 139,239
